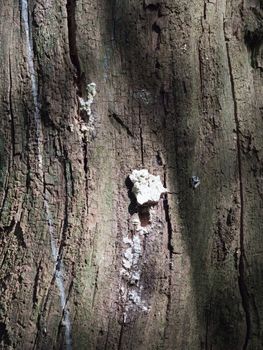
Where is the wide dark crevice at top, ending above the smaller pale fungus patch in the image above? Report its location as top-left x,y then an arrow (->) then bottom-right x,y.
66,0 -> 82,95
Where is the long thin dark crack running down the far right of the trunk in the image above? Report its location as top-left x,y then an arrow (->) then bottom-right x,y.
225,39 -> 251,350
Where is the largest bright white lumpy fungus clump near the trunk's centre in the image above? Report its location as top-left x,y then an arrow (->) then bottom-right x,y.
129,169 -> 167,205
